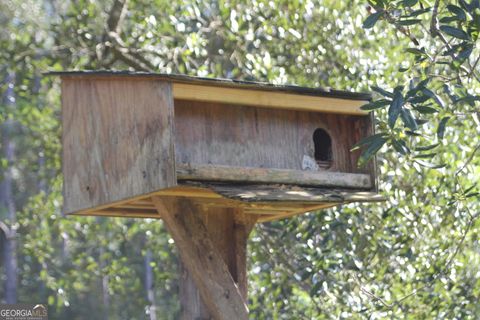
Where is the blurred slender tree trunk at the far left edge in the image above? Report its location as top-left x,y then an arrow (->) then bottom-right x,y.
0,73 -> 18,303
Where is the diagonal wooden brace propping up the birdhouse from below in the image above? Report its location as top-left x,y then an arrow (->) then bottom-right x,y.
152,196 -> 248,320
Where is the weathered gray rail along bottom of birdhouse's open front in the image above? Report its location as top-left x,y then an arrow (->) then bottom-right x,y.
176,163 -> 372,190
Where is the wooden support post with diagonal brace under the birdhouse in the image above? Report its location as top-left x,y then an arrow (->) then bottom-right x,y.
152,197 -> 255,320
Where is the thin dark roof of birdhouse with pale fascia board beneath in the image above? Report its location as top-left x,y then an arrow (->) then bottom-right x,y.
48,71 -> 371,115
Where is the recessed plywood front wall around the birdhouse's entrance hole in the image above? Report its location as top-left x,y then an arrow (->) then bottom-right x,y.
175,100 -> 372,173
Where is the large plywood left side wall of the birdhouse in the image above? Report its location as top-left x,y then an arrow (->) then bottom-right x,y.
62,78 -> 176,213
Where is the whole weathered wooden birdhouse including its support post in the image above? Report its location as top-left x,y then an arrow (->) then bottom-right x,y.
52,72 -> 380,319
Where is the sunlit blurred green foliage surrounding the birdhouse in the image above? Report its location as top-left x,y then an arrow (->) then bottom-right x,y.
0,0 -> 480,319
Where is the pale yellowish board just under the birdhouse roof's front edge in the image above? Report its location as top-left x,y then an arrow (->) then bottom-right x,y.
173,83 -> 368,115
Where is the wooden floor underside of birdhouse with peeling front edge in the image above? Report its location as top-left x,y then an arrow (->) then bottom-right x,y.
68,181 -> 383,222
